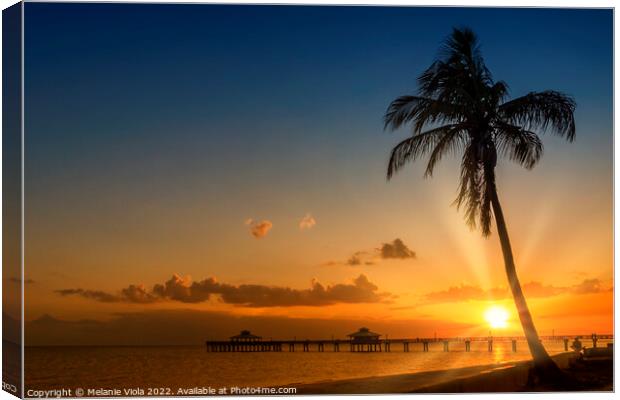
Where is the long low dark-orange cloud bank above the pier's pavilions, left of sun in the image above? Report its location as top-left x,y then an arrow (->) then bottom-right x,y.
56,274 -> 390,307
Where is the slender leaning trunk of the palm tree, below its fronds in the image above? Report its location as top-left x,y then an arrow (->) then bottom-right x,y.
490,184 -> 560,377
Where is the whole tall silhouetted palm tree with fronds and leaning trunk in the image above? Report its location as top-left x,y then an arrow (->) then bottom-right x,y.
385,29 -> 575,376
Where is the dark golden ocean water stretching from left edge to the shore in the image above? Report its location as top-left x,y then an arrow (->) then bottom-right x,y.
25,340 -> 606,391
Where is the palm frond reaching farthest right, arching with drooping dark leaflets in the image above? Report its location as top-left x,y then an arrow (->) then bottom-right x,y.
498,90 -> 576,142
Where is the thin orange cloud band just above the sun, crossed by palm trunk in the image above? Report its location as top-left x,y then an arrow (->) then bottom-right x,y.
425,279 -> 609,303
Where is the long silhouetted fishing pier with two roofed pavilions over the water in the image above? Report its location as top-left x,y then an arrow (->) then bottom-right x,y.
205,328 -> 613,353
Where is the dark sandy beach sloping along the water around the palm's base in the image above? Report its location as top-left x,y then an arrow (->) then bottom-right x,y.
297,352 -> 613,394
